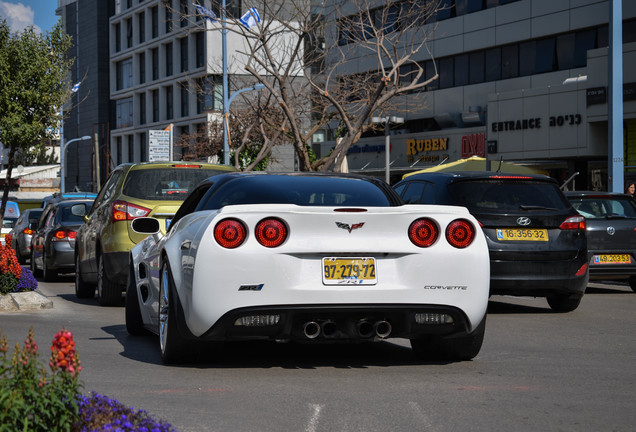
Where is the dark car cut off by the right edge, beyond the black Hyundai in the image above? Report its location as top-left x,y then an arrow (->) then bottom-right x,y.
565,191 -> 636,292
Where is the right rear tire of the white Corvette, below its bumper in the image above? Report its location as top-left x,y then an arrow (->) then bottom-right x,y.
411,315 -> 486,361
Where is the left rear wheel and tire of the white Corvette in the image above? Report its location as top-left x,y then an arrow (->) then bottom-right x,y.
158,262 -> 187,364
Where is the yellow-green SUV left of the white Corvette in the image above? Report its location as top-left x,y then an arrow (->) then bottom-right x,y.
75,162 -> 235,306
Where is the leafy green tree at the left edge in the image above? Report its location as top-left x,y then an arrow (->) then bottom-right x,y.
0,20 -> 73,223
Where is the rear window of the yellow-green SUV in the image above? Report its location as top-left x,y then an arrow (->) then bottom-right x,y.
122,167 -> 223,201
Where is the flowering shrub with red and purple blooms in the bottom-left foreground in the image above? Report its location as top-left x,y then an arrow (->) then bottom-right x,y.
0,328 -> 175,432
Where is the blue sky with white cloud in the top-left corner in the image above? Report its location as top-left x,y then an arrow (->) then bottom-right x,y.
0,0 -> 60,33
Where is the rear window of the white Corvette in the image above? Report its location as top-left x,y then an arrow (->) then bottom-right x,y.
204,175 -> 398,210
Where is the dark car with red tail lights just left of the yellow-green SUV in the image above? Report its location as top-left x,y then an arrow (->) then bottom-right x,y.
31,200 -> 93,281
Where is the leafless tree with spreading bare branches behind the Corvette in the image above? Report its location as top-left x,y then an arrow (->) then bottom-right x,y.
229,0 -> 438,171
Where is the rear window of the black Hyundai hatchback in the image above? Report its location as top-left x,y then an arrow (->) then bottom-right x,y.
448,179 -> 569,213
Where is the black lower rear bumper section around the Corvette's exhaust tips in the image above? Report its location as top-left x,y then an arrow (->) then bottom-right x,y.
190,305 -> 471,343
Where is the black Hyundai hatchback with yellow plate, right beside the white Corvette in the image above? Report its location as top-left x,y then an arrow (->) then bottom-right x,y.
394,171 -> 589,312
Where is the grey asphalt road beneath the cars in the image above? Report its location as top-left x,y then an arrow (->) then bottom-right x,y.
0,277 -> 636,432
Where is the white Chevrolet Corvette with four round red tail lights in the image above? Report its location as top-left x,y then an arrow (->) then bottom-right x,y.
126,172 -> 490,363
